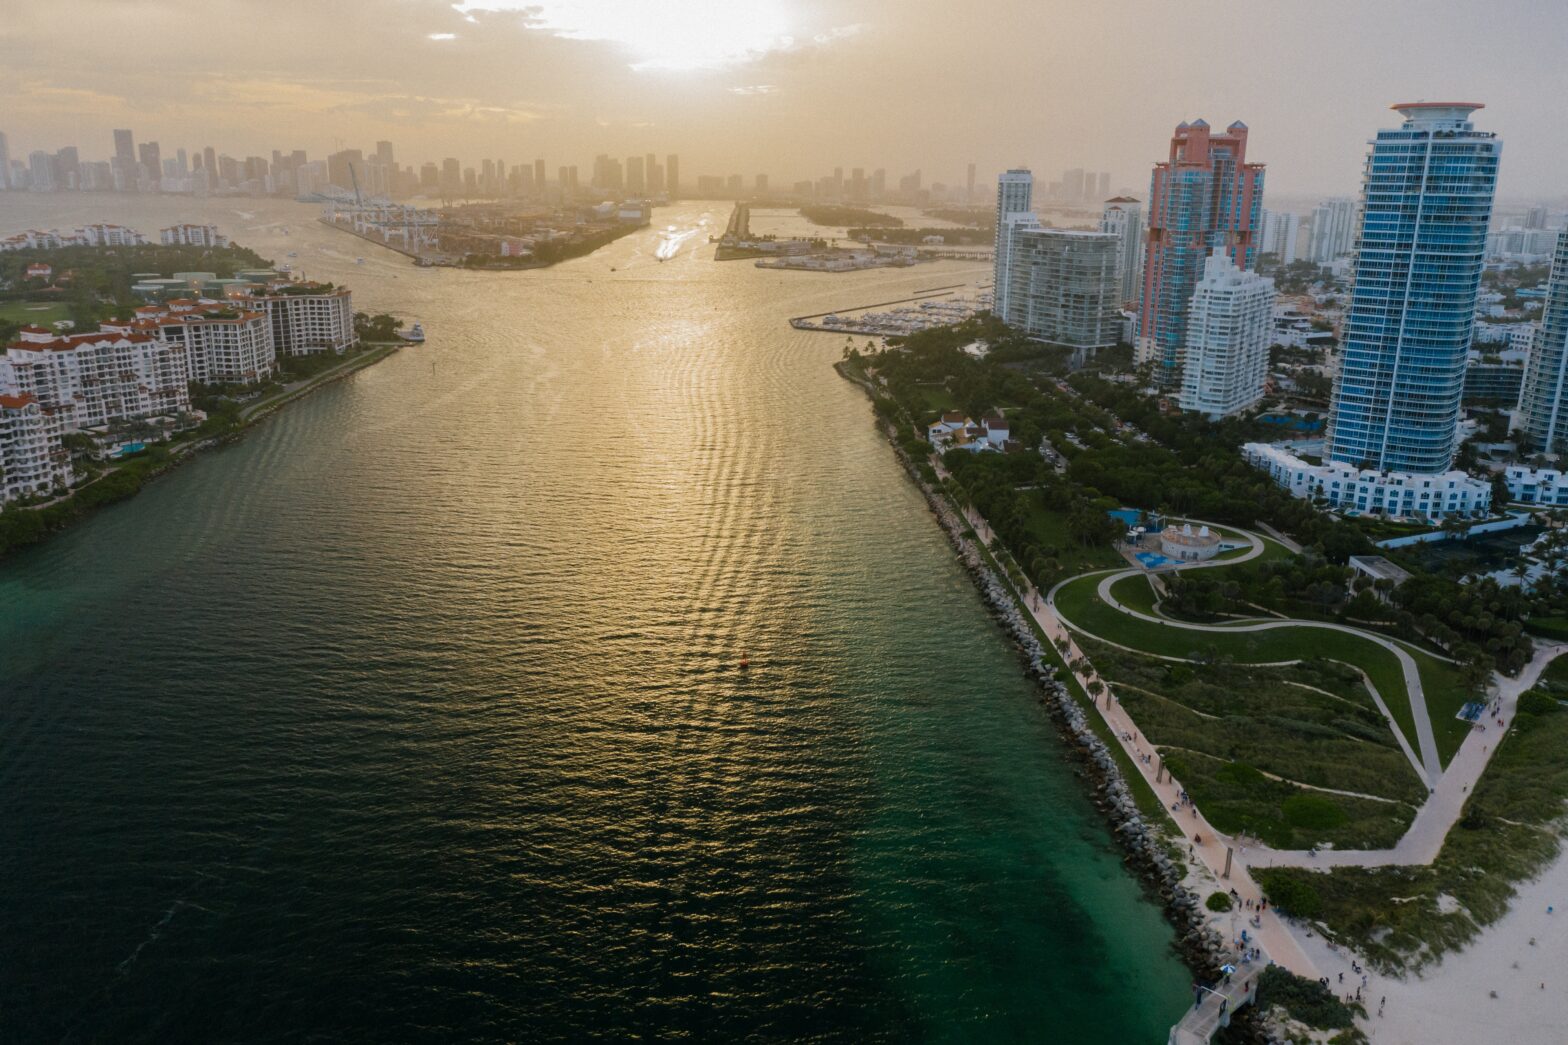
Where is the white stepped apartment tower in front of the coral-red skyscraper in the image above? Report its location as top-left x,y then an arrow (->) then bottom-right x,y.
1179,251 -> 1273,419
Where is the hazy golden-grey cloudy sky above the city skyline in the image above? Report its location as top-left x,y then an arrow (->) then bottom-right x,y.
0,0 -> 1568,201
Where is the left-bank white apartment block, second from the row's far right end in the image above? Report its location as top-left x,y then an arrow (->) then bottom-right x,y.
103,300 -> 278,384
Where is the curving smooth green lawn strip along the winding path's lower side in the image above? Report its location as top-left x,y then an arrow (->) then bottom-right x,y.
1055,573 -> 1419,750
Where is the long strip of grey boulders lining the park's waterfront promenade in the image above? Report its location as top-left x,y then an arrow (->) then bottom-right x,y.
887,425 -> 1228,979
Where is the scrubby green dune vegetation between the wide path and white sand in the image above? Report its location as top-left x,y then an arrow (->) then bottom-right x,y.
1254,690 -> 1568,971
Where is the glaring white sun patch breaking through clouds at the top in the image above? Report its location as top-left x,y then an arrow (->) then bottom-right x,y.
453,0 -> 797,72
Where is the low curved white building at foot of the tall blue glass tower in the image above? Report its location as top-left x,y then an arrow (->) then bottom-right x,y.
1242,442 -> 1491,519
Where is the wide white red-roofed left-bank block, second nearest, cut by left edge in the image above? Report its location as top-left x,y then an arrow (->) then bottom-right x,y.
0,326 -> 191,431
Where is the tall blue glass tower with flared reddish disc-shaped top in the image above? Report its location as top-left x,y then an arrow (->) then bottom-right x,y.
1327,102 -> 1502,474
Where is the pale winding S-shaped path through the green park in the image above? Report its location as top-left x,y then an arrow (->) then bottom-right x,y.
1046,519 -> 1443,788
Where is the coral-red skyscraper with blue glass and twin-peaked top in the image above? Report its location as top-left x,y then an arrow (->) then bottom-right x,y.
1137,119 -> 1264,389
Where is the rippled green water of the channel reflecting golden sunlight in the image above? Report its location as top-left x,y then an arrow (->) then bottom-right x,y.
0,193 -> 1187,1042
